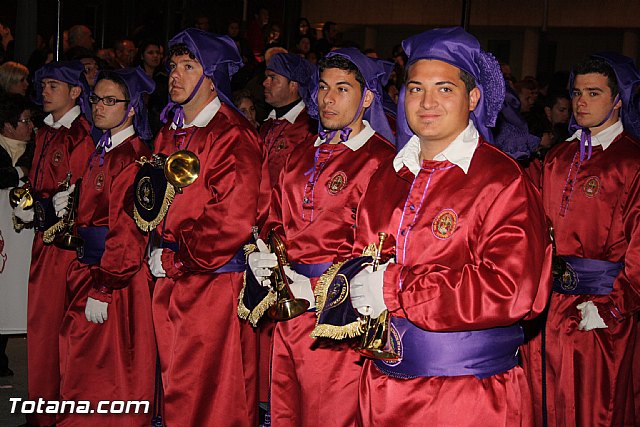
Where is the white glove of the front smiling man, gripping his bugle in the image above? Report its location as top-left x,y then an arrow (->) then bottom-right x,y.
349,263 -> 389,318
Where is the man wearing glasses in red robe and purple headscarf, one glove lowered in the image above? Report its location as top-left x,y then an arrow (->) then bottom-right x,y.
53,68 -> 156,427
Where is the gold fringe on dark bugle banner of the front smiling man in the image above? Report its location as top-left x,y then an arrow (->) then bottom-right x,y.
311,262 -> 365,340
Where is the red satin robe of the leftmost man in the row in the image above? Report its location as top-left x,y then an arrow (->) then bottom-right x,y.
27,115 -> 95,425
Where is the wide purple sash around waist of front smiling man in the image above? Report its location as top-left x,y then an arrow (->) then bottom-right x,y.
374,317 -> 524,379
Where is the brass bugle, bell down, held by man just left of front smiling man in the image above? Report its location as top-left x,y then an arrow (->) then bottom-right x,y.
267,230 -> 310,320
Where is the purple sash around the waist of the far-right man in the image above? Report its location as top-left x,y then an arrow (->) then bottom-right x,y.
553,256 -> 624,295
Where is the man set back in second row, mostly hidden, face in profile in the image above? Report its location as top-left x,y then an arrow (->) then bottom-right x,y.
260,53 -> 318,185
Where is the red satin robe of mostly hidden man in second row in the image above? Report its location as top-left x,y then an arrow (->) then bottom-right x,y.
260,108 -> 318,185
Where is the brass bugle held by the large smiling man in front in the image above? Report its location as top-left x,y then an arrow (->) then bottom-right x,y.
358,232 -> 400,361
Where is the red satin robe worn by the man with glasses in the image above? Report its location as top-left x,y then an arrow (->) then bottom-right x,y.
57,136 -> 156,427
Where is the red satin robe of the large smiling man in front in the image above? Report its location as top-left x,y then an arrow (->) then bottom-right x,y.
354,141 -> 551,427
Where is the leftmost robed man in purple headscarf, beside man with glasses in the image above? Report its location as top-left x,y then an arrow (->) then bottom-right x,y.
14,61 -> 95,426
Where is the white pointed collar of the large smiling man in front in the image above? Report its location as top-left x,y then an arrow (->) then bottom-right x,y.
393,120 -> 480,176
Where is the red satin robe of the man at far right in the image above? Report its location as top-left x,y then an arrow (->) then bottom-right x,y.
531,133 -> 640,426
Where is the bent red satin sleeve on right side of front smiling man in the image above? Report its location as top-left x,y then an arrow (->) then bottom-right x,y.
384,176 -> 551,331
